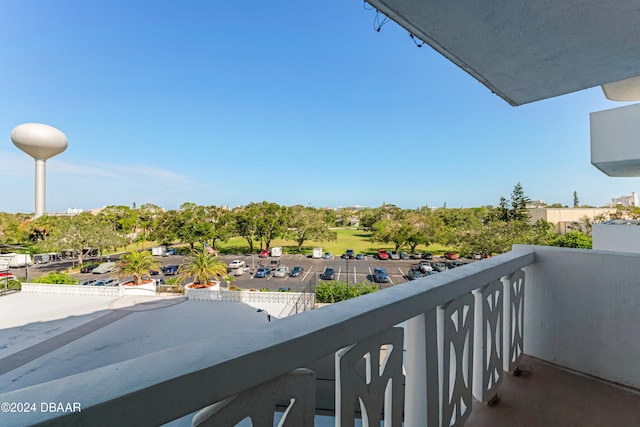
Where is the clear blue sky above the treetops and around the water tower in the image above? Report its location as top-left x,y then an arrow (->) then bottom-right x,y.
0,0 -> 640,212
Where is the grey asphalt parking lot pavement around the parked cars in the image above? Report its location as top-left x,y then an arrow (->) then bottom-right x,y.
12,254 -> 472,291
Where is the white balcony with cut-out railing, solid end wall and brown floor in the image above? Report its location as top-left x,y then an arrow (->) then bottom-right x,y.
0,245 -> 640,427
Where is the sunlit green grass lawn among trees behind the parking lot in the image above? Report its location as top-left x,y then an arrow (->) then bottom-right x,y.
216,228 -> 450,255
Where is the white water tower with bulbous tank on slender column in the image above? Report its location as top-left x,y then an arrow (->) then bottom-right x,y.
11,123 -> 69,218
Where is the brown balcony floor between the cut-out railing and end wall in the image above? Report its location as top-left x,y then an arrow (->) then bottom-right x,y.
465,356 -> 640,427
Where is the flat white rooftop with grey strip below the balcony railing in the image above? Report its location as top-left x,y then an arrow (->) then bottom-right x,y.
0,293 -> 270,393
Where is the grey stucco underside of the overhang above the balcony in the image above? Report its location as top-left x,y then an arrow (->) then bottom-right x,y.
366,0 -> 640,106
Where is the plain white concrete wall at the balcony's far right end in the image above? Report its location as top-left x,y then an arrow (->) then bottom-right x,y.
514,245 -> 640,388
